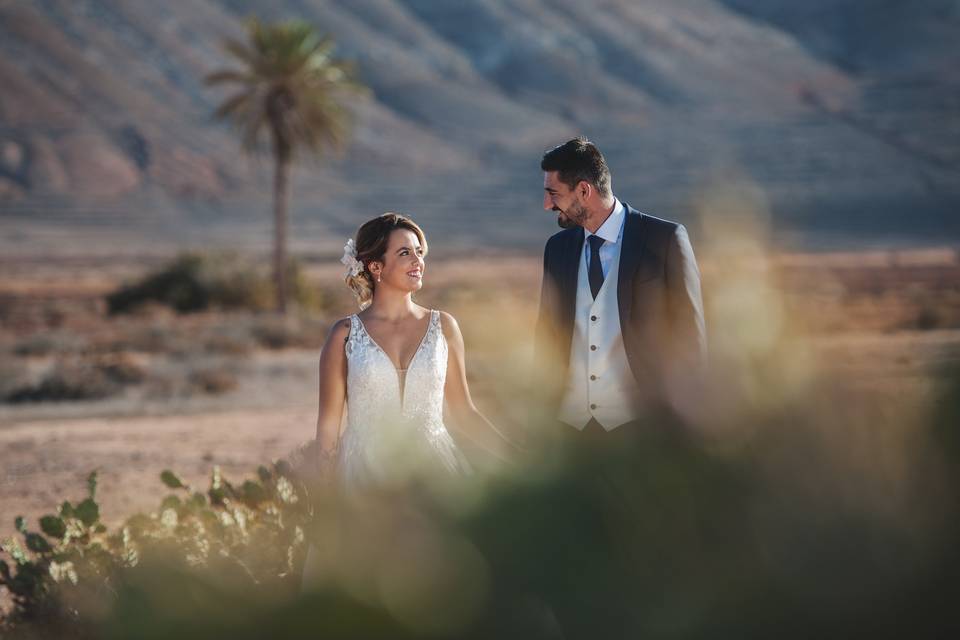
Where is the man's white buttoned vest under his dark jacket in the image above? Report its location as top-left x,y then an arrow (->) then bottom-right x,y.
559,235 -> 638,431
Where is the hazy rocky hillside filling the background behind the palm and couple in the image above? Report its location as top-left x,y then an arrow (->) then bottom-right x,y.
0,0 -> 960,255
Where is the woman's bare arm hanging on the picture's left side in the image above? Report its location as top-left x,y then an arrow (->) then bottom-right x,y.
317,319 -> 350,476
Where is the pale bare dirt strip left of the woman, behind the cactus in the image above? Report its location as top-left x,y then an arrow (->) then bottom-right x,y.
0,408 -> 316,537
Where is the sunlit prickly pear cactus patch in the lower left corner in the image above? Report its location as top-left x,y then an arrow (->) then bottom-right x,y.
0,462 -> 311,638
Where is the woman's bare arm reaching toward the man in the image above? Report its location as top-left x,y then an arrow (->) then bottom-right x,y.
440,311 -> 520,460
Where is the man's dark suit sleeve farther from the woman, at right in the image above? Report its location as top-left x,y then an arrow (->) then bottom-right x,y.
666,225 -> 707,408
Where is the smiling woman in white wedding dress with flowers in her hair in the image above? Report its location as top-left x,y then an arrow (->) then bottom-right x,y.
316,213 -> 510,493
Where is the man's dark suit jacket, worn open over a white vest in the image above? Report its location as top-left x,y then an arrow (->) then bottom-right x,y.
534,203 -> 706,419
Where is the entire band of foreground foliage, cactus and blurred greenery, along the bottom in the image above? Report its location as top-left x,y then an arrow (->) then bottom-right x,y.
0,376 -> 960,639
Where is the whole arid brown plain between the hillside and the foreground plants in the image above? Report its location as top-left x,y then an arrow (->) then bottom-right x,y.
0,249 -> 960,537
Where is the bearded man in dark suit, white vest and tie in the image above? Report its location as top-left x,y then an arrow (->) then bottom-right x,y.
535,137 -> 706,442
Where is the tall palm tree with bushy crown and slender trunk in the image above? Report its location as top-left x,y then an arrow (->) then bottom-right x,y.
206,18 -> 363,313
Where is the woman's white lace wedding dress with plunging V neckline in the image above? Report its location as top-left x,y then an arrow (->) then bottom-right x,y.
338,310 -> 469,489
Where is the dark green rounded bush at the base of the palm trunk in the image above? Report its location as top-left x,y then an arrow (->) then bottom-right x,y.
107,252 -> 320,314
